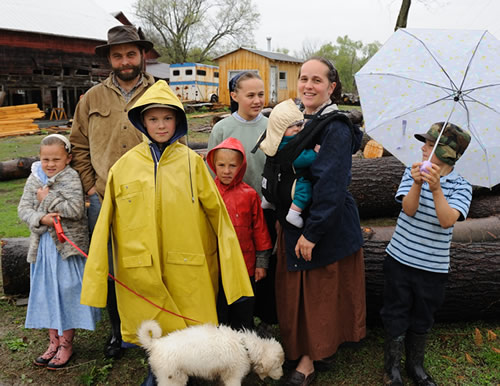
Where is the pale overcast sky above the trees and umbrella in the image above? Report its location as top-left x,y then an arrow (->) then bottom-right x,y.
98,0 -> 500,55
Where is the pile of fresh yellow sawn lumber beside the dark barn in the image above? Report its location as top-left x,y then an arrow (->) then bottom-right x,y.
0,103 -> 45,137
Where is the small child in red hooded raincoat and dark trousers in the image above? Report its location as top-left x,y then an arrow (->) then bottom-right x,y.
207,137 -> 272,329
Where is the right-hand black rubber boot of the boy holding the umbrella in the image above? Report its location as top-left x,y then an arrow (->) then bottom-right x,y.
405,331 -> 436,386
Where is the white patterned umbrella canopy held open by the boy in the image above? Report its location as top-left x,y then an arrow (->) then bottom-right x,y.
355,29 -> 500,188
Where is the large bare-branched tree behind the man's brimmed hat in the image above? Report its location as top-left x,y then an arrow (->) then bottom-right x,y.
134,0 -> 260,63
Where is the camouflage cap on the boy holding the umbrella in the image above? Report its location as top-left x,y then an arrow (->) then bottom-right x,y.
415,122 -> 470,166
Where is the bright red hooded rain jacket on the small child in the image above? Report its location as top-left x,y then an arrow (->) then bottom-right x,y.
207,137 -> 273,276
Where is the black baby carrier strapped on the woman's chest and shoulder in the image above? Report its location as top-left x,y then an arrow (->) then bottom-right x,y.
252,110 -> 360,224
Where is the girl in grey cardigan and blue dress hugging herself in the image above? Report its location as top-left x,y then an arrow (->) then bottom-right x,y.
18,134 -> 100,370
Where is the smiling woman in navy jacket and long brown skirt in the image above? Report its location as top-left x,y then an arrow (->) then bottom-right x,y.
276,58 -> 366,385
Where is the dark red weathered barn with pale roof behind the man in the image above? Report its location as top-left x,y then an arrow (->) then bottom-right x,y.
0,0 -> 159,118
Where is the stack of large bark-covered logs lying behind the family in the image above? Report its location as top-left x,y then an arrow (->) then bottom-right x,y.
2,110 -> 500,323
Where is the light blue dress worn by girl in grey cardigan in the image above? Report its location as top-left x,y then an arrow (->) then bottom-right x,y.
25,164 -> 101,335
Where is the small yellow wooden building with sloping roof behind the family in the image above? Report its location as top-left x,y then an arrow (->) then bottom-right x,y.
215,47 -> 302,106
